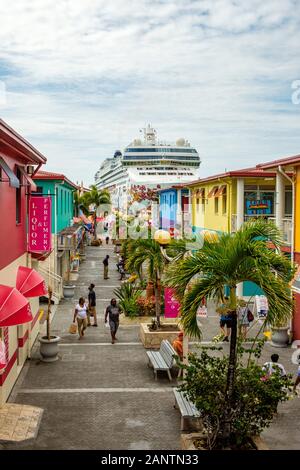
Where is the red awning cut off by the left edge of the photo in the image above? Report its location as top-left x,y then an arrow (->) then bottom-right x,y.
0,285 -> 33,327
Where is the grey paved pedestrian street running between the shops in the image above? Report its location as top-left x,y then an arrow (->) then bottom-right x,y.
0,245 -> 300,450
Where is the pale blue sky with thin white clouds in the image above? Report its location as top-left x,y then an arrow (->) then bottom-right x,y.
0,0 -> 300,185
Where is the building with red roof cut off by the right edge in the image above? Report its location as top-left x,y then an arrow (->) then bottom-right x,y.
258,155 -> 300,340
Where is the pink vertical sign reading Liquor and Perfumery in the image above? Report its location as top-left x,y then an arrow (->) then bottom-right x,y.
28,196 -> 51,253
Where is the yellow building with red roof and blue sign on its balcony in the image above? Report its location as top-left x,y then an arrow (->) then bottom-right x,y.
188,168 -> 292,297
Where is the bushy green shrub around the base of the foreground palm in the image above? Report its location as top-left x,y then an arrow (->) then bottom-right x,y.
180,341 -> 292,448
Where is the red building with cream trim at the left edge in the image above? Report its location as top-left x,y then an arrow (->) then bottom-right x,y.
0,119 -> 46,406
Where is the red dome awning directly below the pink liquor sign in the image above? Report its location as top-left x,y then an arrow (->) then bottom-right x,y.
16,266 -> 47,297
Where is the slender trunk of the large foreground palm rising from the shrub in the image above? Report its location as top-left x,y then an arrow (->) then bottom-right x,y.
222,288 -> 237,446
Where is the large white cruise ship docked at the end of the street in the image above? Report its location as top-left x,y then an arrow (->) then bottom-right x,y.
95,124 -> 201,207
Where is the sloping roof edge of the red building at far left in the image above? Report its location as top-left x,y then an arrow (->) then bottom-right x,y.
0,119 -> 47,164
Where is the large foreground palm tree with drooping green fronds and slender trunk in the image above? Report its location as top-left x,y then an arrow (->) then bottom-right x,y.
167,220 -> 293,440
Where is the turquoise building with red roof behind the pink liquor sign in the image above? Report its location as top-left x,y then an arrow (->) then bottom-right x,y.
34,171 -> 84,301
